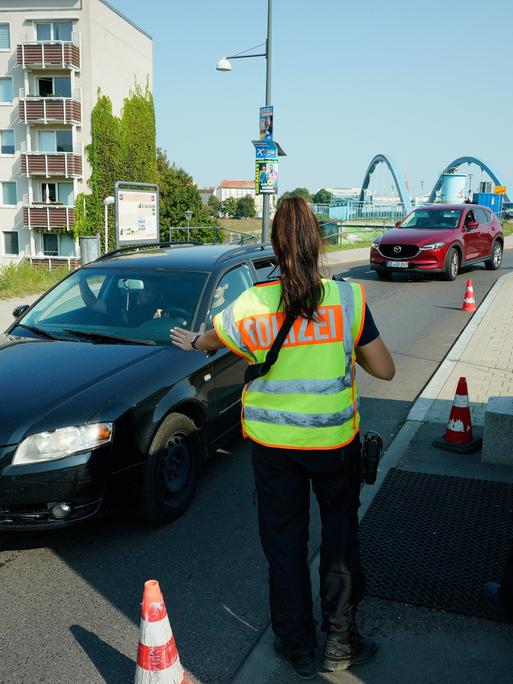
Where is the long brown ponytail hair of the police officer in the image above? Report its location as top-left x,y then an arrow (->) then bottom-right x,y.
271,197 -> 324,321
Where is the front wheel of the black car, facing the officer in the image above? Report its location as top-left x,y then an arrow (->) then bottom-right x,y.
141,413 -> 203,523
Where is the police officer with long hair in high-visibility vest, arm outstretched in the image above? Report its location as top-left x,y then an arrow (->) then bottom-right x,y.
171,198 -> 395,679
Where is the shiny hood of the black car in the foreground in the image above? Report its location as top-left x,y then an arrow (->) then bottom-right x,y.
0,334 -> 173,446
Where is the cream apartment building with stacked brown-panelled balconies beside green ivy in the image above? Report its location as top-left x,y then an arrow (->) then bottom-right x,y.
0,0 -> 153,266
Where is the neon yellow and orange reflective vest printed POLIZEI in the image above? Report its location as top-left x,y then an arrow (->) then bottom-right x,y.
214,280 -> 365,449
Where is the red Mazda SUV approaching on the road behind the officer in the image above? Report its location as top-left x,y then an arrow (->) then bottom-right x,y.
370,204 -> 504,280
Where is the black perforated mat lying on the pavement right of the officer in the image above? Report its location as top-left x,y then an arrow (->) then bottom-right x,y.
361,468 -> 513,619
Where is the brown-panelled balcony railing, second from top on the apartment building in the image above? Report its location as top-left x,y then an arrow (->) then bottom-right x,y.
19,88 -> 82,124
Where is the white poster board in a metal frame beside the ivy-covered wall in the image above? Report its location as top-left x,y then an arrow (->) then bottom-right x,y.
116,188 -> 159,244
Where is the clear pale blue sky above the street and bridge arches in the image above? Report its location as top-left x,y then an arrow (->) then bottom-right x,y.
110,0 -> 513,194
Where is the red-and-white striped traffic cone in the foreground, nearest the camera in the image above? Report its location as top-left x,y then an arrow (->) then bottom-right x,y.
135,580 -> 189,684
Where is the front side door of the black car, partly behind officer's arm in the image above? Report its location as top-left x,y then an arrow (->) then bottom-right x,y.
207,264 -> 253,437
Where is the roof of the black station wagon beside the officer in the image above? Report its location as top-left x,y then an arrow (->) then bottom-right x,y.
85,243 -> 273,271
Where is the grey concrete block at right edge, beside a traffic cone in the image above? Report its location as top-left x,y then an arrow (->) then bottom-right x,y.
481,396 -> 513,466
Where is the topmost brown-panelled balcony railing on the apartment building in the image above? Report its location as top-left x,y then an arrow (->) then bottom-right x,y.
17,33 -> 80,71
